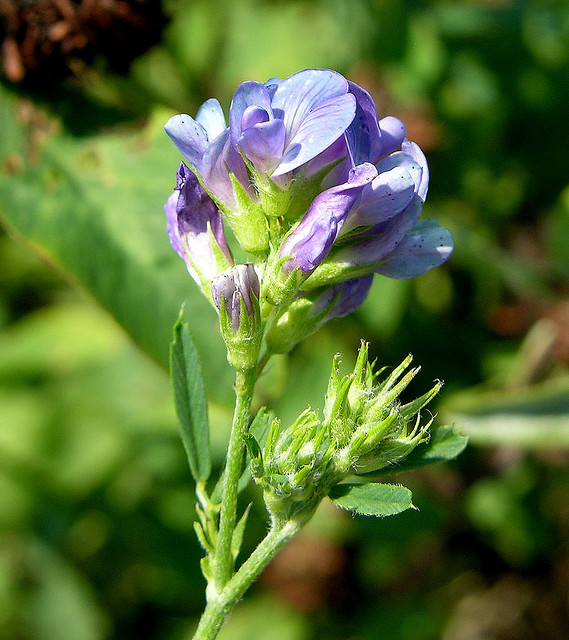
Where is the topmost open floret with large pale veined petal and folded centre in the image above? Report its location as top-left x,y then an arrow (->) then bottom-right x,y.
229,69 -> 356,182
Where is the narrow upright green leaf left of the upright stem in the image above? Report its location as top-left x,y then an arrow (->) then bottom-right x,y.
170,310 -> 211,482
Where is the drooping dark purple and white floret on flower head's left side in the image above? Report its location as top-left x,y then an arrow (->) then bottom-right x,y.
164,163 -> 233,294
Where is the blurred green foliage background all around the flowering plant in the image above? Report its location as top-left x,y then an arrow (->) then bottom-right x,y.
0,0 -> 569,640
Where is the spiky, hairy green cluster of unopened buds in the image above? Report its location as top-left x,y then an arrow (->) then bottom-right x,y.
248,343 -> 442,520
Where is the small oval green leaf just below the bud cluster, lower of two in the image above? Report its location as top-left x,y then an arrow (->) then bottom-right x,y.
328,482 -> 415,518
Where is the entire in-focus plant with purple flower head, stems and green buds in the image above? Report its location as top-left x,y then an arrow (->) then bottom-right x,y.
160,69 -> 462,640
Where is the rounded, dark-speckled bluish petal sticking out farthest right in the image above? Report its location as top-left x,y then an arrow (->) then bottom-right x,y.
376,220 -> 453,280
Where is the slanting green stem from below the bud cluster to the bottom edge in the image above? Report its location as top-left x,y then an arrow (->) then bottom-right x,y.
192,520 -> 304,640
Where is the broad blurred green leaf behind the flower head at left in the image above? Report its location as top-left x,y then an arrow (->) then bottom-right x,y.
0,87 -> 232,401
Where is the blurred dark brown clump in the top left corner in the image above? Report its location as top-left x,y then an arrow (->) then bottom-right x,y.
0,0 -> 166,88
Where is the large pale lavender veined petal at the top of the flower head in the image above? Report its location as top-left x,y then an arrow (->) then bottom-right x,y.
272,69 -> 355,176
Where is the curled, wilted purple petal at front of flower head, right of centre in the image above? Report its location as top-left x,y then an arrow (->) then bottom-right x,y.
279,163 -> 376,274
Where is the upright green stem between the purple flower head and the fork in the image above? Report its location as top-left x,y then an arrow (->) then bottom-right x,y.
212,369 -> 257,598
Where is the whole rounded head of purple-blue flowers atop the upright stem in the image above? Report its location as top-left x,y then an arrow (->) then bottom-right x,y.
165,69 -> 452,364
